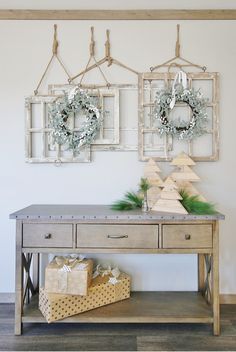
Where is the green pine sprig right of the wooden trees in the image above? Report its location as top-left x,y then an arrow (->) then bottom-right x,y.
179,189 -> 217,215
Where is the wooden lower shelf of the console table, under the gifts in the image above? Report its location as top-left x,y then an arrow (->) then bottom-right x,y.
22,292 -> 213,323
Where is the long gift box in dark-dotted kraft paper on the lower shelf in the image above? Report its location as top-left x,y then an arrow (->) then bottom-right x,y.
39,273 -> 130,323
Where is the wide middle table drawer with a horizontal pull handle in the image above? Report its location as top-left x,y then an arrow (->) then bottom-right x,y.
77,225 -> 158,248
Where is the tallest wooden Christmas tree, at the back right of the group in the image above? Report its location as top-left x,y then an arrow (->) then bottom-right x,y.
171,152 -> 206,201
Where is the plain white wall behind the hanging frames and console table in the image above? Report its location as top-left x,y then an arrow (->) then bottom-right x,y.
0,0 -> 236,293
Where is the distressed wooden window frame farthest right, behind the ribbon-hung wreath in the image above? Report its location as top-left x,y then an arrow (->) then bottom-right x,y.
138,72 -> 219,161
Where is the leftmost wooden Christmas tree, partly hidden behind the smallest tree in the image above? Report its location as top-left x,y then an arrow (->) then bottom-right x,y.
144,159 -> 163,209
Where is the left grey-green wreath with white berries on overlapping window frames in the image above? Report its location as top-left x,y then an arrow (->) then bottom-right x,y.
49,86 -> 101,153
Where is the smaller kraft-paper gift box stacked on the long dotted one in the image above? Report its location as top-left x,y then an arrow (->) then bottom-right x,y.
45,256 -> 93,296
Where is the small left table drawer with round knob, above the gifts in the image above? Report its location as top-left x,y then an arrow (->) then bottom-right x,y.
23,224 -> 73,248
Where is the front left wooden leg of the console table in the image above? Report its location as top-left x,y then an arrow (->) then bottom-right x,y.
15,220 -> 23,335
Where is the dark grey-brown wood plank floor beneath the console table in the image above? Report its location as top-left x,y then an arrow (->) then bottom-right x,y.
0,304 -> 236,351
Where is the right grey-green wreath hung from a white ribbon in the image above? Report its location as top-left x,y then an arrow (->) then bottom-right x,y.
153,71 -> 207,140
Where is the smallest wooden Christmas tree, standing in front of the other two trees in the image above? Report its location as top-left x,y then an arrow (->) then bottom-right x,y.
152,177 -> 188,214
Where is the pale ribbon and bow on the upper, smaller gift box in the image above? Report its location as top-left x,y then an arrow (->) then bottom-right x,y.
53,255 -> 87,292
